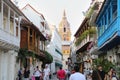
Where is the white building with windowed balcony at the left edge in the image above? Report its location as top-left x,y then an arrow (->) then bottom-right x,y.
0,0 -> 23,80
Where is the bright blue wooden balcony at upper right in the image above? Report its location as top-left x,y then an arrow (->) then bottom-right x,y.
95,0 -> 120,50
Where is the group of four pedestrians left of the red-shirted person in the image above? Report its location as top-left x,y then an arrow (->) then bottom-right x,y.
18,64 -> 50,80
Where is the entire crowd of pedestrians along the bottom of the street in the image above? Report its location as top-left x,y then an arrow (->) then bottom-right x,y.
18,65 -> 119,80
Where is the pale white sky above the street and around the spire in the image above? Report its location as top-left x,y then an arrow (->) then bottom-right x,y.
17,0 -> 92,40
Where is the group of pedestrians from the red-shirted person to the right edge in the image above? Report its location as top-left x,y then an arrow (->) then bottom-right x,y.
57,65 -> 119,80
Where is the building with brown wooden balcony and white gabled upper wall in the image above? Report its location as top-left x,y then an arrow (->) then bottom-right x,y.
21,4 -> 52,74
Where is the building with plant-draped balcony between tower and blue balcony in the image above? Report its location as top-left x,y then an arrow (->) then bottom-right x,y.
75,18 -> 96,72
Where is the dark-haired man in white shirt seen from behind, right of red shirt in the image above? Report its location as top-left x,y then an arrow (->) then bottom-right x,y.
69,66 -> 86,80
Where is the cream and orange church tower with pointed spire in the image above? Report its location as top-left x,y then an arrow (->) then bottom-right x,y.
58,11 -> 71,69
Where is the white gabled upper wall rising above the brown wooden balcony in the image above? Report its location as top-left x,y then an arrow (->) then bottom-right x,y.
22,4 -> 50,37
